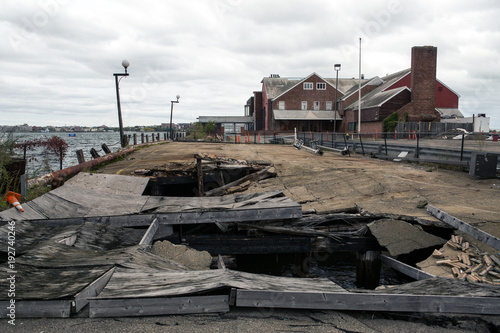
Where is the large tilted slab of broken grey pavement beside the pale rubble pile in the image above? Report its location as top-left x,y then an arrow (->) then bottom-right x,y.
368,219 -> 446,257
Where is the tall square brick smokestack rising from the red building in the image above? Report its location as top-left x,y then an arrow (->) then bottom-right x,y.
411,46 -> 437,117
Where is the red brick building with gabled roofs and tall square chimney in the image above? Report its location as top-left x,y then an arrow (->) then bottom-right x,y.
252,46 -> 463,133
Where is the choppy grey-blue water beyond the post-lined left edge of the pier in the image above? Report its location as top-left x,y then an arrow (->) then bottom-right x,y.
5,132 -> 137,178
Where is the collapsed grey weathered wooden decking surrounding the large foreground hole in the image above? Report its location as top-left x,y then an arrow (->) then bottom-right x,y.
0,175 -> 500,318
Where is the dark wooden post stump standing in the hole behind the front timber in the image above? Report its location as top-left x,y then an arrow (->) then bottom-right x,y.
356,251 -> 381,289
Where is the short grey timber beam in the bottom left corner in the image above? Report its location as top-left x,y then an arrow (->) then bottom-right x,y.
0,300 -> 71,319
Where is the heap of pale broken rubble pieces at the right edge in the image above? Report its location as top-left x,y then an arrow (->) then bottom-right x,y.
432,235 -> 500,285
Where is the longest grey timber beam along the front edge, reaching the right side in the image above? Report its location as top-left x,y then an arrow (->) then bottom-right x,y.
236,290 -> 500,315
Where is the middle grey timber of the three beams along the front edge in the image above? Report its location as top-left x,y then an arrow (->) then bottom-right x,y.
89,295 -> 229,318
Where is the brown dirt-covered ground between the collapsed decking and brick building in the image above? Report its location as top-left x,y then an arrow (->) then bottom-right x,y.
99,142 -> 500,249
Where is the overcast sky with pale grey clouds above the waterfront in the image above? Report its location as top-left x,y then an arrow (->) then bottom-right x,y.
0,0 -> 500,129
